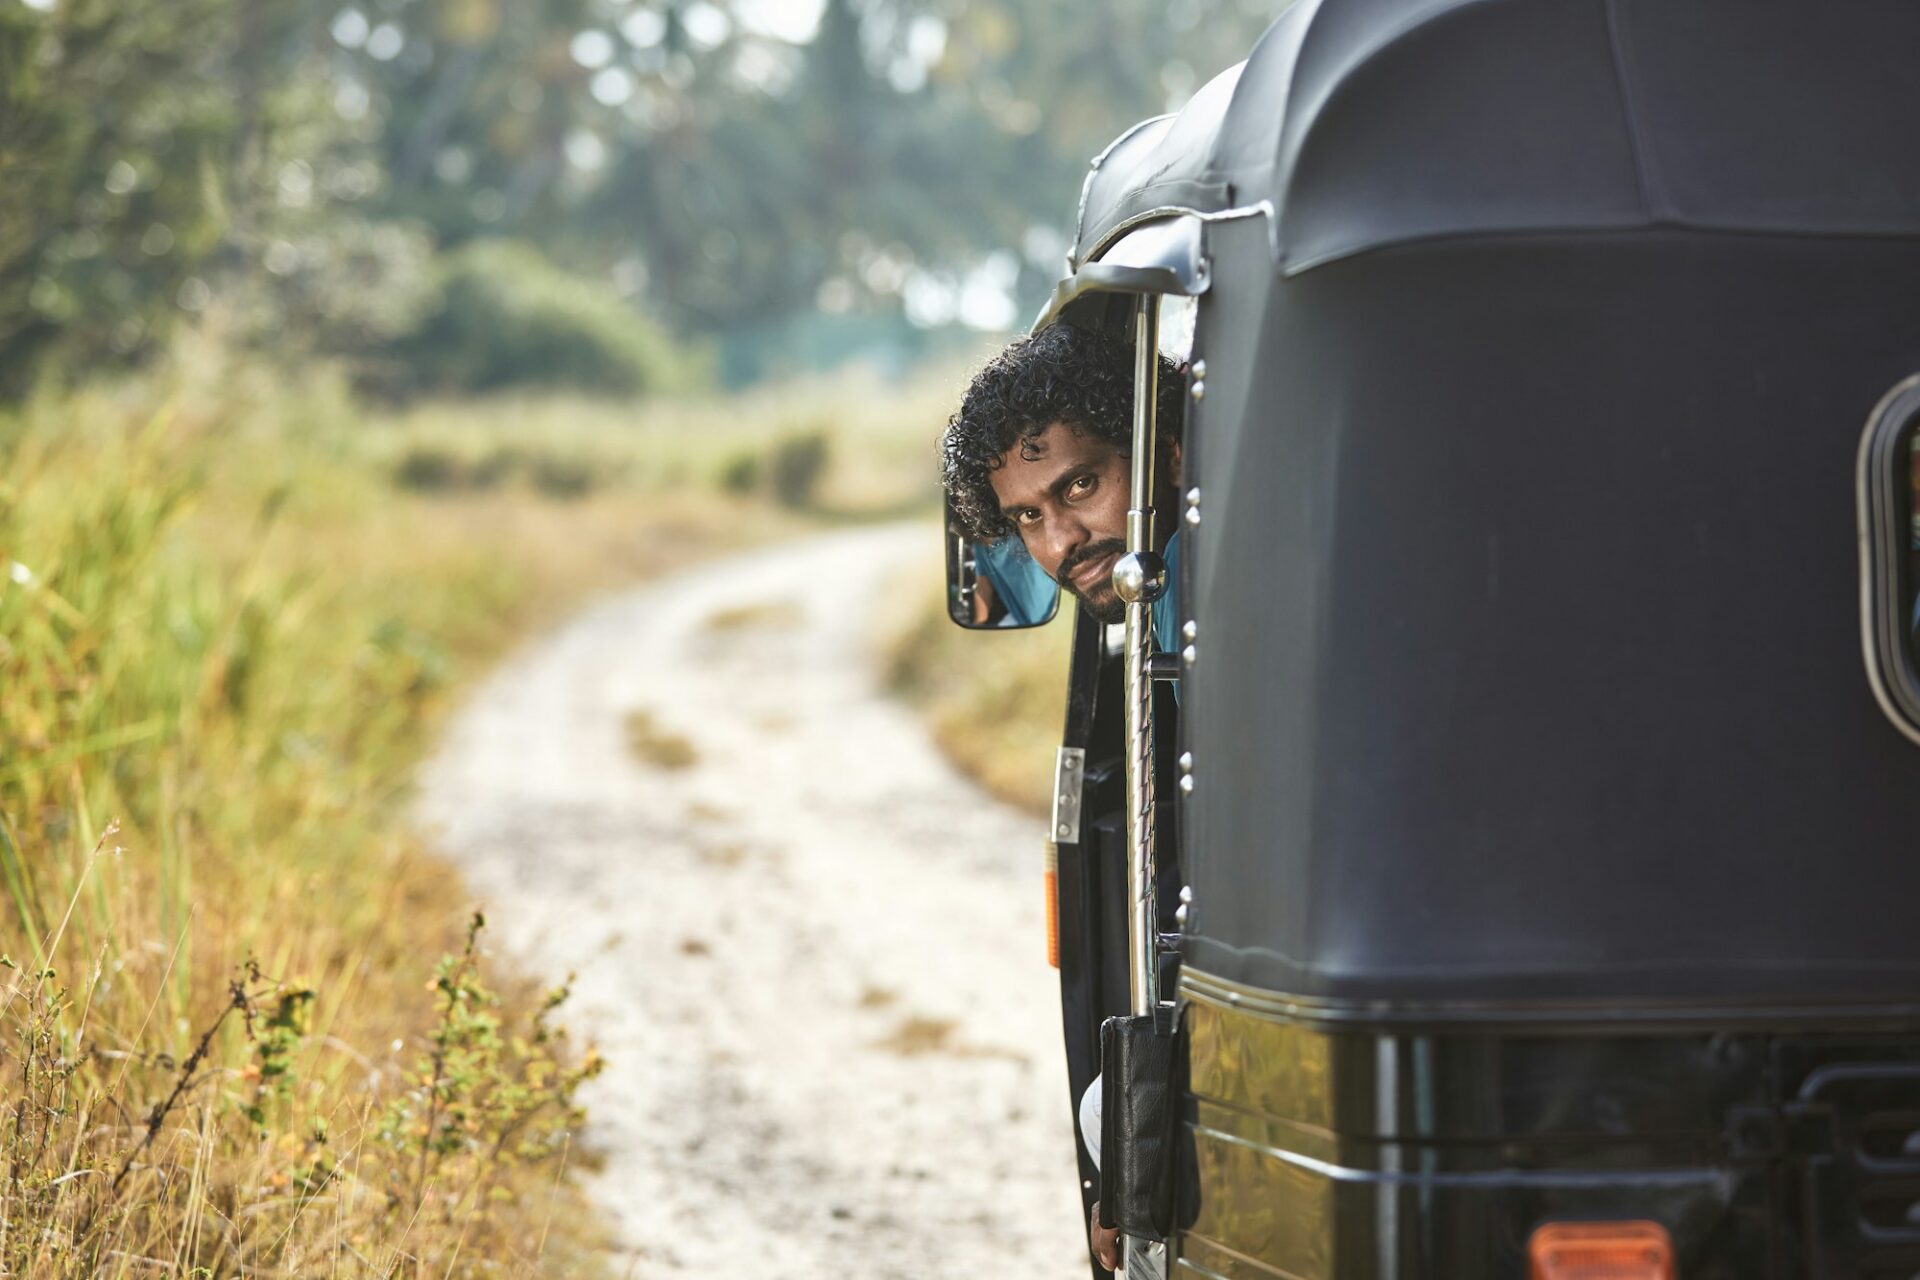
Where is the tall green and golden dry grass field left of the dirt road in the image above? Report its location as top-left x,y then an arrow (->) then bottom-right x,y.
0,339 -> 945,1276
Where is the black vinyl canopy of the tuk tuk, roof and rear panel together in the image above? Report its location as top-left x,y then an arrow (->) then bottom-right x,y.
1113,0 -> 1920,1007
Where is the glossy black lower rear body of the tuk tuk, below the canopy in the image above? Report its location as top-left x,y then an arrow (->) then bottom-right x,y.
1173,975 -> 1920,1280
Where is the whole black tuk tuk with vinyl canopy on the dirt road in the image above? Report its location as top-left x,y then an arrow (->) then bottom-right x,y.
947,0 -> 1920,1280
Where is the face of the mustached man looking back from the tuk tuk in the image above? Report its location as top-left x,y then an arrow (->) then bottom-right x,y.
993,422 -> 1131,622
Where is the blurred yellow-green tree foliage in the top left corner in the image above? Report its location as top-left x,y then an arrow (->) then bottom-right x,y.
0,0 -> 372,391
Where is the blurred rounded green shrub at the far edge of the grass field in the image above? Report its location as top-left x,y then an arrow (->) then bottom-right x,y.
388,240 -> 707,395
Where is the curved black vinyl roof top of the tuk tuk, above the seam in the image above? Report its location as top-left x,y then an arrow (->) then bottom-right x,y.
1073,0 -> 1920,273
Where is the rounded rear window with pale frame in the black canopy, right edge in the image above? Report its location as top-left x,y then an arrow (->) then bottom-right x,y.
1860,376 -> 1920,743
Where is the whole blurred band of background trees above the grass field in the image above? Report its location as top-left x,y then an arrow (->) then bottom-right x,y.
0,0 -> 1284,395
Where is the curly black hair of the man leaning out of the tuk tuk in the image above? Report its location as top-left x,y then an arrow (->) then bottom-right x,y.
941,324 -> 1185,541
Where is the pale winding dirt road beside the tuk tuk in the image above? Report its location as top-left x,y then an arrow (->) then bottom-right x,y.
420,526 -> 1087,1280
